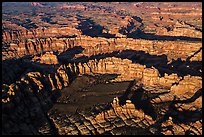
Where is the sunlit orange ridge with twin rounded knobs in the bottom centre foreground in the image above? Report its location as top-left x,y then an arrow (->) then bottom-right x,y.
49,98 -> 154,135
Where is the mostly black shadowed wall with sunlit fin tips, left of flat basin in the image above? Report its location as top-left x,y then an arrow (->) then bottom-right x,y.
2,64 -> 77,135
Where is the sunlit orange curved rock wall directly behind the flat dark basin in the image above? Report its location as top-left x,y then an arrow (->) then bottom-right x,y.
78,57 -> 178,87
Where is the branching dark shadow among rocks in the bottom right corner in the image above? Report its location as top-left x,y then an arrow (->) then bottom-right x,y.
147,89 -> 202,134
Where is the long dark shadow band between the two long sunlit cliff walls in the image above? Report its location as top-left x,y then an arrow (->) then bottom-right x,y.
73,50 -> 202,77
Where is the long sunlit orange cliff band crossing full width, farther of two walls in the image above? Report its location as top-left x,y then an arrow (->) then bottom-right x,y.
2,36 -> 202,61
